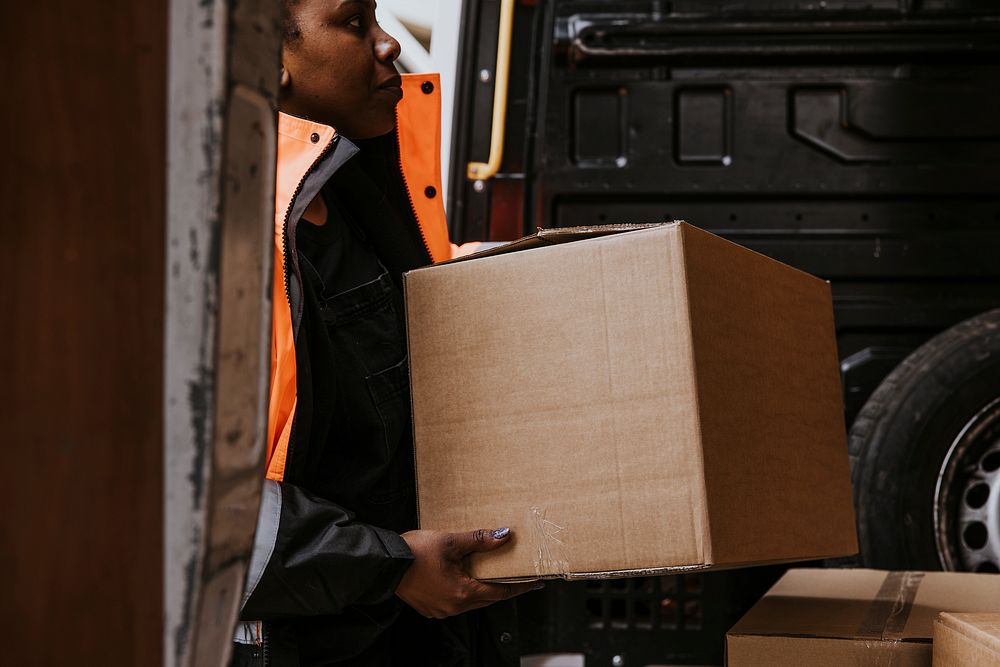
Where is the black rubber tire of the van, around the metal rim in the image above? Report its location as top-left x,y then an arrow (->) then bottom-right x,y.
849,309 -> 1000,570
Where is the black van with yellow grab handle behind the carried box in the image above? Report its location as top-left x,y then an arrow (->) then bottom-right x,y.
449,0 -> 1000,665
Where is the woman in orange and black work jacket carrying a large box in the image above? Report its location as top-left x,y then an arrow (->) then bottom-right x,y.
228,0 -> 533,667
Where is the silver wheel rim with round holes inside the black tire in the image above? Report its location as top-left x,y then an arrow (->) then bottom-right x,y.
934,398 -> 1000,572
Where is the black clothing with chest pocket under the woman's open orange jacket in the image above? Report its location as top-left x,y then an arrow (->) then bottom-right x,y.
296,167 -> 426,667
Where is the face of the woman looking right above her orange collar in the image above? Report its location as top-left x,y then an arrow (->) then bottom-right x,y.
280,0 -> 403,139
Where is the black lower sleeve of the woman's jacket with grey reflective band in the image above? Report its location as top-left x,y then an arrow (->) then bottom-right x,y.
240,480 -> 413,621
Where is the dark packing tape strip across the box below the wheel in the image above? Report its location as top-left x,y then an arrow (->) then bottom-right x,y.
857,572 -> 924,667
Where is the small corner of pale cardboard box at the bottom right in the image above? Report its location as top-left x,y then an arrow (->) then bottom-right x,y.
934,613 -> 1000,667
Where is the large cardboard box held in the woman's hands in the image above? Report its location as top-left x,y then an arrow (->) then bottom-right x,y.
405,223 -> 856,580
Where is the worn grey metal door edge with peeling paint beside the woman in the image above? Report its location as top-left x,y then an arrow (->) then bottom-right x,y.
164,0 -> 281,667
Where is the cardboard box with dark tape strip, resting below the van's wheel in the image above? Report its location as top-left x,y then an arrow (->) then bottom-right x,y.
726,569 -> 1000,667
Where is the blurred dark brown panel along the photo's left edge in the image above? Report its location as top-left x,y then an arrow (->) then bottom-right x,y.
0,0 -> 167,666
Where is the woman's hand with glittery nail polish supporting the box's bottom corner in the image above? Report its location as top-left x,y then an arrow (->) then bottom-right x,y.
396,528 -> 542,618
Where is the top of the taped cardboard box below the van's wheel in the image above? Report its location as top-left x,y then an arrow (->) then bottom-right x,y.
730,569 -> 1000,642
